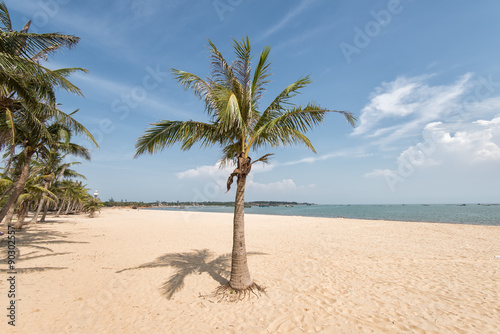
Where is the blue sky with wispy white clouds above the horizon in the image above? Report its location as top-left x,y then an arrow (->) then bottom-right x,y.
6,0 -> 500,204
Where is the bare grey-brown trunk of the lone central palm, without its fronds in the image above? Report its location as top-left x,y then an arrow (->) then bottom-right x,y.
229,173 -> 253,290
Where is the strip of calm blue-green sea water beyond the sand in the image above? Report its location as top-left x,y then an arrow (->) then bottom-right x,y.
149,204 -> 500,226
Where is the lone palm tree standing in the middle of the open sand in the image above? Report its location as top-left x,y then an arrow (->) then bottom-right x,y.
136,37 -> 356,294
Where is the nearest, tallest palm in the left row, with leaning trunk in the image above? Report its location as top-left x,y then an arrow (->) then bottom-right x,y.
0,1 -> 97,222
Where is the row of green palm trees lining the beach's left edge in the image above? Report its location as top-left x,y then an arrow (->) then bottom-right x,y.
0,1 -> 97,227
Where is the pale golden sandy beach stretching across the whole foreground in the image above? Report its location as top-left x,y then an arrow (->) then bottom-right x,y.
0,209 -> 500,333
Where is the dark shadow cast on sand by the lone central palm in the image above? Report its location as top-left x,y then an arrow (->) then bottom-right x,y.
117,249 -> 268,299
